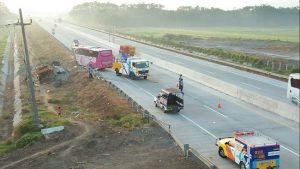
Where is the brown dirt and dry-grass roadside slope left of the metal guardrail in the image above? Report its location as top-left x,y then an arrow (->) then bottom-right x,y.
0,25 -> 202,169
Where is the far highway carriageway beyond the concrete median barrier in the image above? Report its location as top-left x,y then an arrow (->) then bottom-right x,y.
52,21 -> 289,103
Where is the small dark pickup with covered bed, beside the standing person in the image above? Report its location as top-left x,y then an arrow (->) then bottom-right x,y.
154,88 -> 184,113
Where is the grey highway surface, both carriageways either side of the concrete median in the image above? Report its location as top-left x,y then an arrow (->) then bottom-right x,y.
39,20 -> 299,169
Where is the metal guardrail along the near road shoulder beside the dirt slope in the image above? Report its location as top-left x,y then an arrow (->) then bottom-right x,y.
94,71 -> 218,169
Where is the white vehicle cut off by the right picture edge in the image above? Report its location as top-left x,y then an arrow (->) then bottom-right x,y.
287,73 -> 300,105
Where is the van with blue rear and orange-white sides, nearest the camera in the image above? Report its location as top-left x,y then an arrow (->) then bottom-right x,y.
216,131 -> 280,169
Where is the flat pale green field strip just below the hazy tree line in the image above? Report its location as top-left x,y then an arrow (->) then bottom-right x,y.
118,27 -> 299,42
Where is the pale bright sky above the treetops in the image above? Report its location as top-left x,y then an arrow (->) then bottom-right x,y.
0,0 -> 299,16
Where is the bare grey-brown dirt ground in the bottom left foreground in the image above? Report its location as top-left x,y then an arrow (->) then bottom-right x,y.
0,123 -> 200,169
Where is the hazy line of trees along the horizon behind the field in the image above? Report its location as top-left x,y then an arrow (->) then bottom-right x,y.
69,1 -> 299,27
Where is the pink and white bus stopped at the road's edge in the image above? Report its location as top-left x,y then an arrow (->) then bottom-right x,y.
74,46 -> 114,69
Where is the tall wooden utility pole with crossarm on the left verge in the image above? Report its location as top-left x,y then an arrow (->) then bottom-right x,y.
16,8 -> 40,127
